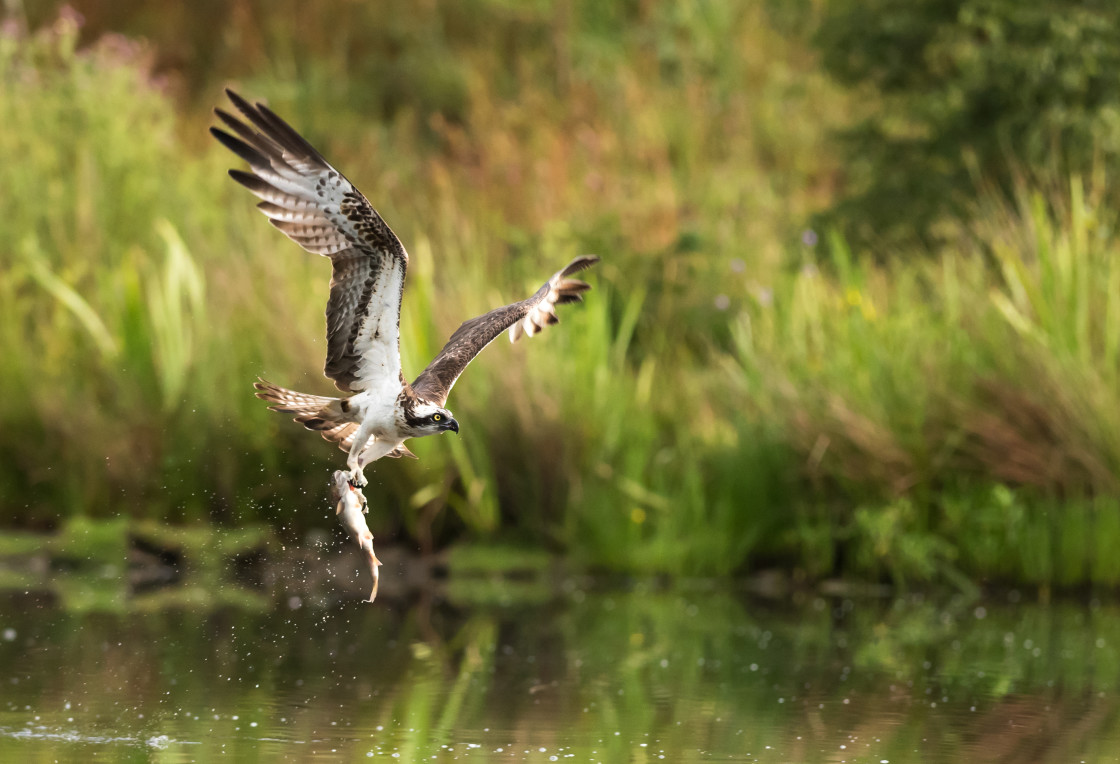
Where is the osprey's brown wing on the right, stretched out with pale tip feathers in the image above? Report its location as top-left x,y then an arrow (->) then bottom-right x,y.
412,254 -> 599,406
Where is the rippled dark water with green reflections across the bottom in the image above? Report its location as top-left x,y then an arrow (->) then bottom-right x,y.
0,587 -> 1120,763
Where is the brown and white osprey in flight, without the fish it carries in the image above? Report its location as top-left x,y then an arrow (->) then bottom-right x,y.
211,90 -> 599,486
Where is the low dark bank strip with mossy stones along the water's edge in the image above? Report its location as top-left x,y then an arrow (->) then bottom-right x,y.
10,521 -> 1120,613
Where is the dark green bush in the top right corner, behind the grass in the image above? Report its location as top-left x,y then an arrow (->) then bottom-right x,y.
815,0 -> 1120,248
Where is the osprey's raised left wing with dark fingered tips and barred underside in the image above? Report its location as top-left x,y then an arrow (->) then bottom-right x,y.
211,90 -> 409,392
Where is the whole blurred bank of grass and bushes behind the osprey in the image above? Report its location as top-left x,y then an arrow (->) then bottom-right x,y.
0,0 -> 1120,588
